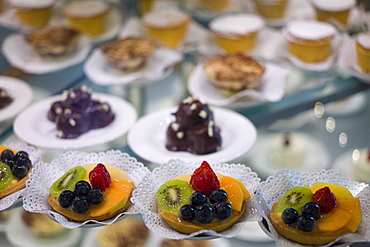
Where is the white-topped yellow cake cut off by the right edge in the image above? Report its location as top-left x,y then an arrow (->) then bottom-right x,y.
356,33 -> 370,73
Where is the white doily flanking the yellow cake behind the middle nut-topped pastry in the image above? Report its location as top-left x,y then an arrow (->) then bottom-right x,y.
118,17 -> 207,52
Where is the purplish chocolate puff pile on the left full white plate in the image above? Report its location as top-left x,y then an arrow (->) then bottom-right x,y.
47,86 -> 115,139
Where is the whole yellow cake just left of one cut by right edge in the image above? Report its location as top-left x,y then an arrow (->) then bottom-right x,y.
285,20 -> 337,63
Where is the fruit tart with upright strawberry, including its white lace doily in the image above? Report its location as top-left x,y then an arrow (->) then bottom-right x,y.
133,160 -> 259,239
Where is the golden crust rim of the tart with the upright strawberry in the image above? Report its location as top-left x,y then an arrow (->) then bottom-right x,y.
158,201 -> 246,234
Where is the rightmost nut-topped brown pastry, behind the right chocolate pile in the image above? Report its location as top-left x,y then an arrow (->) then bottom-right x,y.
204,53 -> 265,91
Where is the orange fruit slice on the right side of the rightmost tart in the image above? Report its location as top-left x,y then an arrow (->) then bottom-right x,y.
337,198 -> 362,232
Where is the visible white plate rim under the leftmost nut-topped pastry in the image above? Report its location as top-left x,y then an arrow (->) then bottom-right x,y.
2,33 -> 91,74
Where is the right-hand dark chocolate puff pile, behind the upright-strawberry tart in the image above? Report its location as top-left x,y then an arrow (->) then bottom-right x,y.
166,97 -> 222,154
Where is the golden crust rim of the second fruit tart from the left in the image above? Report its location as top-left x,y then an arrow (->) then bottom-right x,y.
48,191 -> 132,222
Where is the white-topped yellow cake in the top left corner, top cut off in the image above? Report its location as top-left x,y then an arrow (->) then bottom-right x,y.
10,0 -> 55,27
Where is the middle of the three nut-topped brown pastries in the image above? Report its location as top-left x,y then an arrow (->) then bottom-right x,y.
100,37 -> 158,71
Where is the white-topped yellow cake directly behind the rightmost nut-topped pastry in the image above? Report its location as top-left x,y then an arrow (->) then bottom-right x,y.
209,14 -> 264,53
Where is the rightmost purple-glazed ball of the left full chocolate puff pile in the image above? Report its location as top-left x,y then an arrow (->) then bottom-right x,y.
86,100 -> 114,129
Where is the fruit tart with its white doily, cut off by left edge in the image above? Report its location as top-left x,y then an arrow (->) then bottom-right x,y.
0,143 -> 41,203
